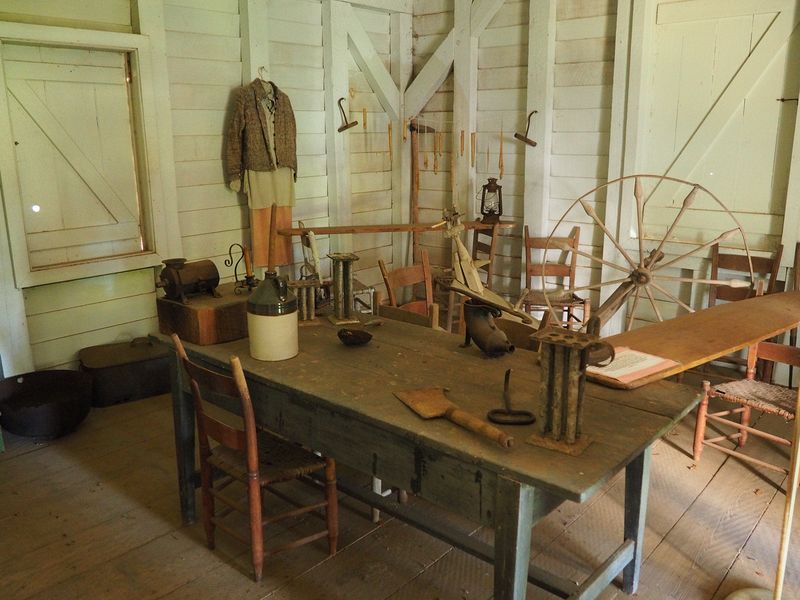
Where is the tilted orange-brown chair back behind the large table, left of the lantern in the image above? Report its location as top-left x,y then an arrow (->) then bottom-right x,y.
378,248 -> 439,329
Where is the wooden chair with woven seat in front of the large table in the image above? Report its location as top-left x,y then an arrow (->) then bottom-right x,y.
172,334 -> 338,581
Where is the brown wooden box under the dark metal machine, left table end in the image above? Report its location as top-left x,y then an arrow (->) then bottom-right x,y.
156,282 -> 249,346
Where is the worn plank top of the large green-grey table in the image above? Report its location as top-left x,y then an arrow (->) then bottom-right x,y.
160,321 -> 699,501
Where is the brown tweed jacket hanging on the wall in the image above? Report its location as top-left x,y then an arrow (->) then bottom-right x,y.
223,79 -> 297,184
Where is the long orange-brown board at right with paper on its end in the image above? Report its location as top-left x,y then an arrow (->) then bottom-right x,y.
589,291 -> 800,389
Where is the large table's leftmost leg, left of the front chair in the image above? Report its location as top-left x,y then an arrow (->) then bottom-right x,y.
170,352 -> 196,524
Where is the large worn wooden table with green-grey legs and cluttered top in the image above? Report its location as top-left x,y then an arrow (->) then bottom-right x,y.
161,321 -> 699,600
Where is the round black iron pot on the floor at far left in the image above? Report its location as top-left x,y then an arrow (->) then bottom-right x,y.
0,370 -> 92,440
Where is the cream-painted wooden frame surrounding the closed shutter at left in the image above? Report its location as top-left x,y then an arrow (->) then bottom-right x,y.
0,22 -> 180,288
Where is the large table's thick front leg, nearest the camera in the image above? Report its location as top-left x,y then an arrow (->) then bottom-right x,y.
494,477 -> 534,600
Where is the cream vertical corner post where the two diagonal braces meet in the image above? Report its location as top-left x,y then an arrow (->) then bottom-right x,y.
390,13 -> 413,268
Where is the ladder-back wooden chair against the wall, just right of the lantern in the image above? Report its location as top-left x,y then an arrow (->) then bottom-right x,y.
523,225 -> 591,324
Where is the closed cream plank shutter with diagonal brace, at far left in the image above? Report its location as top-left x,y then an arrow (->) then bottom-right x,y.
2,44 -> 145,270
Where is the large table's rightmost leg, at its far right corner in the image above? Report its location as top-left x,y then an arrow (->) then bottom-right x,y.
622,446 -> 653,594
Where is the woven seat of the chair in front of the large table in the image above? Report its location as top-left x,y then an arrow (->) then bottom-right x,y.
208,431 -> 325,485
